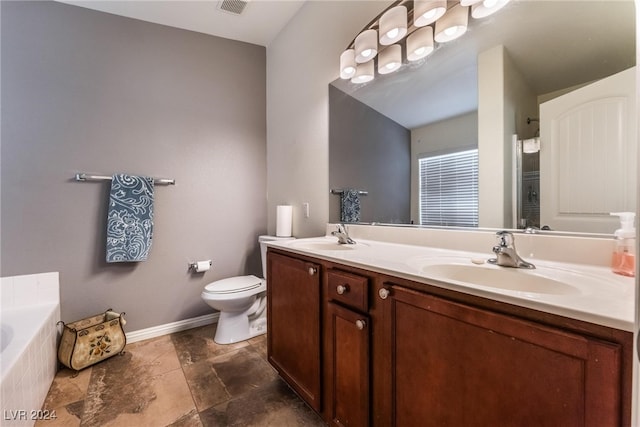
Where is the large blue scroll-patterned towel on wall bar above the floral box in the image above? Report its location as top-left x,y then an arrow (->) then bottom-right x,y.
107,174 -> 153,262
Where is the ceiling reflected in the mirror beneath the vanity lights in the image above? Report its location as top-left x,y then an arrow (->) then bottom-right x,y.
333,0 -> 635,129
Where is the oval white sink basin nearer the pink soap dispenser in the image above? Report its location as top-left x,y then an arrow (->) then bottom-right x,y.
410,259 -> 595,295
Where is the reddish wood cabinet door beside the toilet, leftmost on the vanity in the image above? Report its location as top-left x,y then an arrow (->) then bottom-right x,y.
267,252 -> 321,411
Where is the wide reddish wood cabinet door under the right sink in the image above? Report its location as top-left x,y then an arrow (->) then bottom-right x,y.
376,286 -> 622,427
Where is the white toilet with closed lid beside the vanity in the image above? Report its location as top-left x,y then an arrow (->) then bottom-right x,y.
202,236 -> 293,344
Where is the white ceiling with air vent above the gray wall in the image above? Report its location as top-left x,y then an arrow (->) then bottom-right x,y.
58,0 -> 305,46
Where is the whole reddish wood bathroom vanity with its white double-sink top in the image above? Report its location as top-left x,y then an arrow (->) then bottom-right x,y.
267,234 -> 633,427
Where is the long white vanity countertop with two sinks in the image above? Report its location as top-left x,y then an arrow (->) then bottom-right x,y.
268,236 -> 635,332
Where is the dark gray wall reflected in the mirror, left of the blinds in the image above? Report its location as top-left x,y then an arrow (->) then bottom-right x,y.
329,85 -> 411,224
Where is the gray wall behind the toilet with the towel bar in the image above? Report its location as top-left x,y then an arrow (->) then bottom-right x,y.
0,1 -> 267,331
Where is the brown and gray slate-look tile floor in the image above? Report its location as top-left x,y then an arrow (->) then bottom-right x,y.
36,325 -> 324,427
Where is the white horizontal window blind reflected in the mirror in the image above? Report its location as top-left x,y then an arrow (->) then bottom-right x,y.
419,149 -> 478,227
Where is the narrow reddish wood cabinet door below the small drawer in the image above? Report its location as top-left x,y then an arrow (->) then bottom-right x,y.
325,303 -> 370,427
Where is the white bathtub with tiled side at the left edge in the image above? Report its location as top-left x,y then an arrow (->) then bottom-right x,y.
0,273 -> 60,426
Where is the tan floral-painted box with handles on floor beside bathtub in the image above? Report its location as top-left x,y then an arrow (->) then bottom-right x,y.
58,309 -> 127,371
